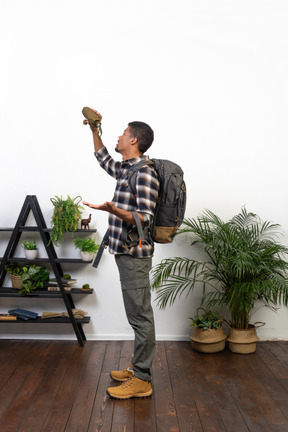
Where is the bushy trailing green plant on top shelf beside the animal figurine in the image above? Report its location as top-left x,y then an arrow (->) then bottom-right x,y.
50,195 -> 84,246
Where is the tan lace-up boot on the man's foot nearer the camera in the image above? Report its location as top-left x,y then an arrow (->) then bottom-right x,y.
107,377 -> 152,399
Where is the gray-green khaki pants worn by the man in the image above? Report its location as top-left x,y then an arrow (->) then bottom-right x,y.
115,254 -> 155,381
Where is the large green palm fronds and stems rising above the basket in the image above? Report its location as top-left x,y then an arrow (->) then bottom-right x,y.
152,208 -> 288,329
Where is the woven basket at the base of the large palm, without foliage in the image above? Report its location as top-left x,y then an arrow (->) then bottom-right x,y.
227,325 -> 259,354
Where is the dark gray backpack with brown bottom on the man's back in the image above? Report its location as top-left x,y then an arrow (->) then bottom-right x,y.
124,159 -> 186,246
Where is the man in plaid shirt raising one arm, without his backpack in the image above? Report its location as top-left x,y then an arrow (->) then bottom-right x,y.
83,111 -> 159,399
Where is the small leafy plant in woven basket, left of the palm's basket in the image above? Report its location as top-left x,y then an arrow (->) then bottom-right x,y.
190,308 -> 227,353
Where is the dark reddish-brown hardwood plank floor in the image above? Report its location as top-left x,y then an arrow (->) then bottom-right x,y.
0,340 -> 288,432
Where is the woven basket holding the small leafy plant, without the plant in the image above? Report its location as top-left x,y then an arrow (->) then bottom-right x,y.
190,327 -> 227,354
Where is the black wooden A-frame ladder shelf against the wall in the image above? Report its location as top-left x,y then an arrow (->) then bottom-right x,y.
0,195 -> 96,347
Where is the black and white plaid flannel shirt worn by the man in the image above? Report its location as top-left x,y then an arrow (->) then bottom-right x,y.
95,146 -> 159,258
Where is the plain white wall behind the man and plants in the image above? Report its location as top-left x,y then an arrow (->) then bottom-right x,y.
0,0 -> 288,339
